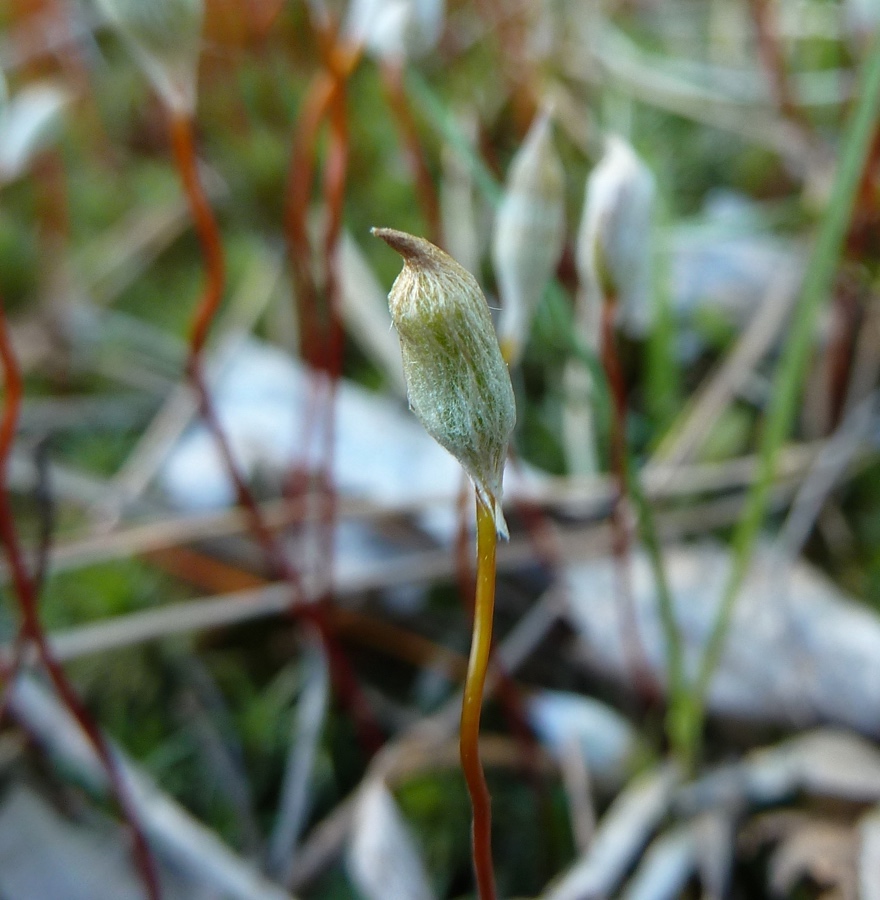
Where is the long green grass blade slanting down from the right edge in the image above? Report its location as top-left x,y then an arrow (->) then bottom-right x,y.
685,37 -> 880,751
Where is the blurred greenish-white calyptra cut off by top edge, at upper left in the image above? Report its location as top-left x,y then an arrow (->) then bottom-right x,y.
95,0 -> 205,115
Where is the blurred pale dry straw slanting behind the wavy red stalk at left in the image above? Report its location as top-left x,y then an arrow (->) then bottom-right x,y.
101,254 -> 282,528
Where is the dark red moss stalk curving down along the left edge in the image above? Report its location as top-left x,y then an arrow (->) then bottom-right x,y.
0,305 -> 161,900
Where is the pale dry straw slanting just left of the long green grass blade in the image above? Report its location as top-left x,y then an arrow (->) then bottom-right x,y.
645,266 -> 802,478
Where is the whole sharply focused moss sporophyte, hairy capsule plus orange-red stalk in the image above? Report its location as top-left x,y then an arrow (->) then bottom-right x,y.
373,228 -> 516,900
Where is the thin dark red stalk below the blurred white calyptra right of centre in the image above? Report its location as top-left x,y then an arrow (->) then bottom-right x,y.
602,297 -> 657,699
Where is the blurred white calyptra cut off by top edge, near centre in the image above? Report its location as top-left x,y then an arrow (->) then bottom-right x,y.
345,0 -> 446,63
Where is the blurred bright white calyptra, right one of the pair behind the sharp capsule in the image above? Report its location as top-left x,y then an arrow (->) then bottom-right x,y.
576,134 -> 656,336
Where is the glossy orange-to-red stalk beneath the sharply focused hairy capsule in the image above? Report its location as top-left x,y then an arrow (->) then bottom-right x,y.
459,496 -> 497,900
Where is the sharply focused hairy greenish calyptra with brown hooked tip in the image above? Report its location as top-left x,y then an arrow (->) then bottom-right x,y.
373,228 -> 516,537
